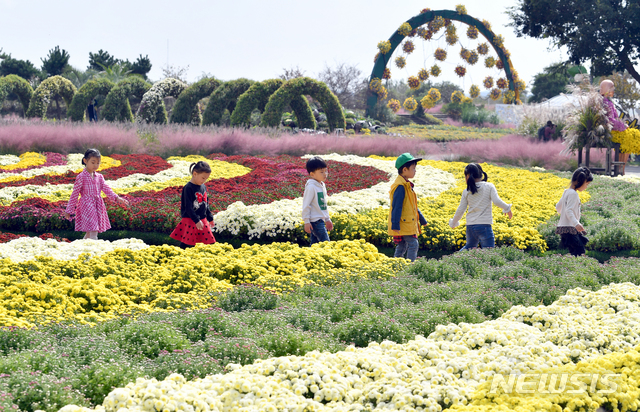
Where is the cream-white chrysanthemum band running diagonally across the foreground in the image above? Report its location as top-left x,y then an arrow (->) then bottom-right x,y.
60,283 -> 640,412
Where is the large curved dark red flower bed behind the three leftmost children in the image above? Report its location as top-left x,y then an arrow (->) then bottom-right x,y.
0,155 -> 389,233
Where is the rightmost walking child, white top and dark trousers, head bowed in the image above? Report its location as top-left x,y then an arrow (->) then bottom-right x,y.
556,166 -> 593,256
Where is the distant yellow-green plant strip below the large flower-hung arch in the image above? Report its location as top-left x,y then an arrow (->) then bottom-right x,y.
387,124 -> 513,142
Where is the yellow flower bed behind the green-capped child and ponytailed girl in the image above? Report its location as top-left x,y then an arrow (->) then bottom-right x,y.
331,156 -> 589,251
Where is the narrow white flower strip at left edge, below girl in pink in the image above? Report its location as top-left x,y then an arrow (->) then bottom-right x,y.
0,237 -> 149,262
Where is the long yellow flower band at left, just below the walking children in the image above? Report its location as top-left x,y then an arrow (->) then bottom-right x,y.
0,241 -> 408,327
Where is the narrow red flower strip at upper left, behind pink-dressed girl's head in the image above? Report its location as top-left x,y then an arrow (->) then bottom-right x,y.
0,154 -> 171,188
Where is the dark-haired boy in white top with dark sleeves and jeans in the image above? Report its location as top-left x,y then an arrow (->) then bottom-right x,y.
302,156 -> 333,245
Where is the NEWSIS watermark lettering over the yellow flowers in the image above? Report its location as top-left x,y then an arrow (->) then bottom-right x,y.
489,372 -> 620,395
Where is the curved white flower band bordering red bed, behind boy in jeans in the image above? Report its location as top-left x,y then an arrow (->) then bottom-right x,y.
214,154 -> 455,238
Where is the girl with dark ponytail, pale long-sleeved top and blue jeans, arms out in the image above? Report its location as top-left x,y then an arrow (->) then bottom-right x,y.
449,163 -> 513,250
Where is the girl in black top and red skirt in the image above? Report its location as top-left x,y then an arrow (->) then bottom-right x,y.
170,161 -> 216,249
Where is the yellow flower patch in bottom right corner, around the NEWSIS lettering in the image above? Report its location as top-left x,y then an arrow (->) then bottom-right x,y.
448,346 -> 640,412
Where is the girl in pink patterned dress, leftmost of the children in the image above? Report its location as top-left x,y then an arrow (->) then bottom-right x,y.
64,149 -> 129,240
